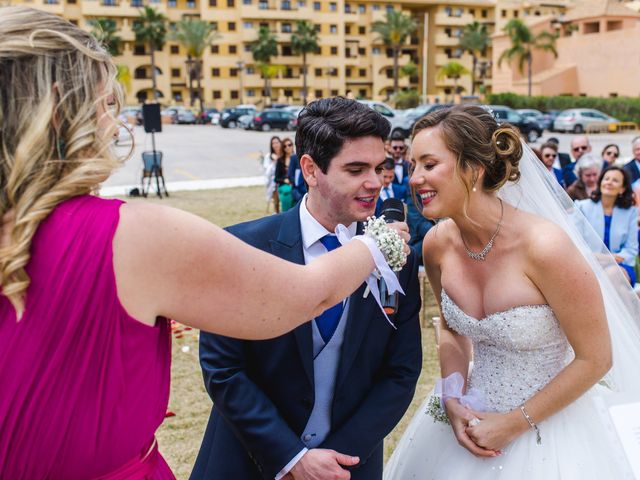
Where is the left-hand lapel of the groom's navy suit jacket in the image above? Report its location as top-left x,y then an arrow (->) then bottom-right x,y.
270,203 -> 313,385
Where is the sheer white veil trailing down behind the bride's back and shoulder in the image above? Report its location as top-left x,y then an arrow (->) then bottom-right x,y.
498,142 -> 640,399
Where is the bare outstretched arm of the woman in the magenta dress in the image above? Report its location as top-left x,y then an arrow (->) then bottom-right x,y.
113,203 -> 374,339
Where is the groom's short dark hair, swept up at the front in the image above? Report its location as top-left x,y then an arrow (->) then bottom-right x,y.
296,97 -> 391,173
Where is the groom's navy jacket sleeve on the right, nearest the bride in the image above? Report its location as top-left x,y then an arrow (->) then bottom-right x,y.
320,254 -> 422,462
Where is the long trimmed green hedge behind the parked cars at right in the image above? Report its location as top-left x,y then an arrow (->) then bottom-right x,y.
487,93 -> 640,122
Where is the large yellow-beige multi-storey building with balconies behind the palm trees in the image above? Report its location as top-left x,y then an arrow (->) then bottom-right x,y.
7,0 -> 624,108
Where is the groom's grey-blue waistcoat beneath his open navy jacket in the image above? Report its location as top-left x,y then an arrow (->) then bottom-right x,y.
300,301 -> 349,448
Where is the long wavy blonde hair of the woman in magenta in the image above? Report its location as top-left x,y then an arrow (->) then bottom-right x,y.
0,7 -> 122,319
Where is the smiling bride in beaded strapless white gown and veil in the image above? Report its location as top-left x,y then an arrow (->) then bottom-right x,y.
385,106 -> 640,480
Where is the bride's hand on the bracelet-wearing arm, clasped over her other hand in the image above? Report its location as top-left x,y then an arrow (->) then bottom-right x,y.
465,410 -> 529,453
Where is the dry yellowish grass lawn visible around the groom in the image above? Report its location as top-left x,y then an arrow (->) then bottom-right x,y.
128,187 -> 439,479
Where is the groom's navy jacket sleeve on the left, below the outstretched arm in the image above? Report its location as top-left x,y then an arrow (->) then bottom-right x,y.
200,332 -> 305,479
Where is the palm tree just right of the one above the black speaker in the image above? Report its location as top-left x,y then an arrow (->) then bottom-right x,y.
170,18 -> 221,115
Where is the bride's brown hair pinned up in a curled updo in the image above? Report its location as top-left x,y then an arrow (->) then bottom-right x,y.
412,105 -> 522,193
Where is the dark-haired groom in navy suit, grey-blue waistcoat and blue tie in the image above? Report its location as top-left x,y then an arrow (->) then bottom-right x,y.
191,98 -> 422,480
